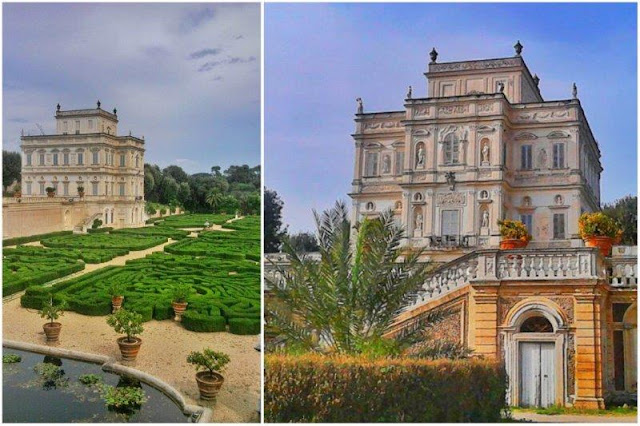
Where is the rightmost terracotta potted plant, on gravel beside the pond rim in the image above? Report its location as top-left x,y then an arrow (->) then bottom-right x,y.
187,348 -> 230,400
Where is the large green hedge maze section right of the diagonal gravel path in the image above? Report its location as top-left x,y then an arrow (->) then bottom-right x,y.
21,215 -> 261,334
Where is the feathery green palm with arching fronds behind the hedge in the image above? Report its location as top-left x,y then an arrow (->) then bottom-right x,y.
265,202 -> 443,355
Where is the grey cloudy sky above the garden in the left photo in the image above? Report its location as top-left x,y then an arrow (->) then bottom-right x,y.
2,3 -> 261,173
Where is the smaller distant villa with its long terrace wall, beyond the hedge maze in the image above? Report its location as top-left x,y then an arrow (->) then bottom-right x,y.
3,101 -> 145,237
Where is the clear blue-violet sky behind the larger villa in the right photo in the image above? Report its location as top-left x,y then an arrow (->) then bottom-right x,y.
265,3 -> 637,231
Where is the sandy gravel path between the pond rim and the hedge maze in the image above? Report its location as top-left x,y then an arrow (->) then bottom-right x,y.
2,299 -> 261,423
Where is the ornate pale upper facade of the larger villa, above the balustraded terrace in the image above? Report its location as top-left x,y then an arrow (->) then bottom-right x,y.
350,50 -> 602,256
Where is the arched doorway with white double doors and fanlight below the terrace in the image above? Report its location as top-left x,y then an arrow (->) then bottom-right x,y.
502,301 -> 568,407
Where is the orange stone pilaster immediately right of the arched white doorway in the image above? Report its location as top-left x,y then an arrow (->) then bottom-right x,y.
574,293 -> 604,408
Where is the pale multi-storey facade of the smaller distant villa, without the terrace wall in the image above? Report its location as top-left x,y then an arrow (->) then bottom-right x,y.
21,103 -> 145,227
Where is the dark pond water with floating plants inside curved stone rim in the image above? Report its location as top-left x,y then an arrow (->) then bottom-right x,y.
2,348 -> 189,423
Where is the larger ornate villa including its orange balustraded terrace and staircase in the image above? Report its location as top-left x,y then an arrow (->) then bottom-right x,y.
265,42 -> 637,408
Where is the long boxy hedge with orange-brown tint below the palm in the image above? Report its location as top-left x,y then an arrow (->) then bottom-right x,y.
264,354 -> 507,423
